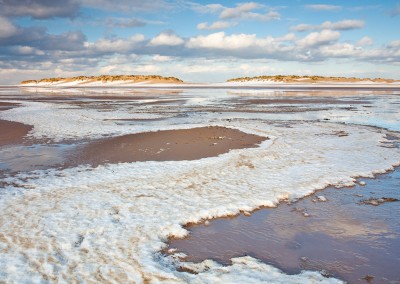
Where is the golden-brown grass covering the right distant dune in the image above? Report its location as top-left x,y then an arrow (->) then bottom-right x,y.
228,75 -> 398,83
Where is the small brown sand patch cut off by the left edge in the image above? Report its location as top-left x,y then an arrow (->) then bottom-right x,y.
0,120 -> 33,147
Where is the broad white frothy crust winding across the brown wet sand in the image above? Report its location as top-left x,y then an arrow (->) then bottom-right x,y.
0,88 -> 400,283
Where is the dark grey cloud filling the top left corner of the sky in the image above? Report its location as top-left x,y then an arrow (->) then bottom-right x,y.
0,0 -> 79,19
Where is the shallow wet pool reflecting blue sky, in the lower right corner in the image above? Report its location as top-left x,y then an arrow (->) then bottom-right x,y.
168,169 -> 400,283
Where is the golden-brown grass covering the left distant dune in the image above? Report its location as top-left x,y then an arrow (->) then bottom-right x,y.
21,75 -> 183,84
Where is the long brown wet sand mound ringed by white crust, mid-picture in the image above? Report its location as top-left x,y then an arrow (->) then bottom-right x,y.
67,126 -> 268,166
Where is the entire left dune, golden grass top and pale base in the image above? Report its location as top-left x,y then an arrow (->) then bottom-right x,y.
20,75 -> 183,86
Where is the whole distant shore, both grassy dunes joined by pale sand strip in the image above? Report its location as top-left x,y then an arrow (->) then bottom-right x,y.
17,75 -> 400,89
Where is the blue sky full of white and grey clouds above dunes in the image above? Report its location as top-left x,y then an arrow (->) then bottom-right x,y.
0,0 -> 400,85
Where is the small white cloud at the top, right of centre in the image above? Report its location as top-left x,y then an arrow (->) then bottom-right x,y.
219,2 -> 280,21
